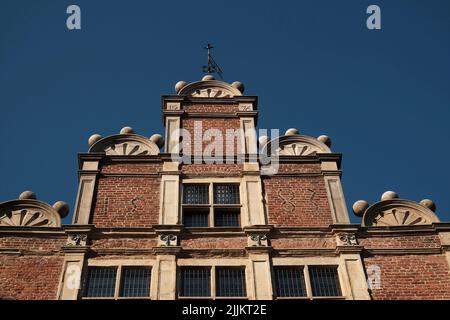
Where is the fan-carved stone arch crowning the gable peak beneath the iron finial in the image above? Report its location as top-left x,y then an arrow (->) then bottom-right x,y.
178,80 -> 242,98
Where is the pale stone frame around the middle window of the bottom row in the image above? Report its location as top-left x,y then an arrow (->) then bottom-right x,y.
176,258 -> 251,300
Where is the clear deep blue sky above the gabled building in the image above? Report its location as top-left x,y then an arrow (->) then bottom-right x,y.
0,0 -> 450,223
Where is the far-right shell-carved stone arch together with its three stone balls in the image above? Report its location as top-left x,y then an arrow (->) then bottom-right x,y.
353,191 -> 439,227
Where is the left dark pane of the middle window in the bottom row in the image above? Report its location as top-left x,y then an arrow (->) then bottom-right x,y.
180,268 -> 211,297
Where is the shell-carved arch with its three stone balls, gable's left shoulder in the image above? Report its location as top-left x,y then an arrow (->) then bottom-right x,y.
88,127 -> 164,156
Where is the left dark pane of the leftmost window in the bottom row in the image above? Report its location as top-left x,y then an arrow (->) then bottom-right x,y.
84,267 -> 117,298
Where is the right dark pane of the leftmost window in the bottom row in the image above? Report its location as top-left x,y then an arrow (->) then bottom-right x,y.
120,267 -> 150,297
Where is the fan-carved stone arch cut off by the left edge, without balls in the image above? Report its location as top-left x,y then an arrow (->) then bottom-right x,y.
0,199 -> 61,227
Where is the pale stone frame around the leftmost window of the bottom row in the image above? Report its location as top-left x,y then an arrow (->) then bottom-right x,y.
80,259 -> 156,300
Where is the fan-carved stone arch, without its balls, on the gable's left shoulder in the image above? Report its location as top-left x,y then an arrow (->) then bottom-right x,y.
89,134 -> 159,156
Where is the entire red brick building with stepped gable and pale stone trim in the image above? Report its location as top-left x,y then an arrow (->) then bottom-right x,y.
0,75 -> 450,299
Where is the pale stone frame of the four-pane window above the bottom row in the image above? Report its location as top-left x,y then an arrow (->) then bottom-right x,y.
180,177 -> 246,229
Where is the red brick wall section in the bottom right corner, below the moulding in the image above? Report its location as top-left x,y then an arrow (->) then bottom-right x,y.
363,254 -> 450,300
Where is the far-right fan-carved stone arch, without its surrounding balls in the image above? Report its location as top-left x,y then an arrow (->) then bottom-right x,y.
363,199 -> 439,227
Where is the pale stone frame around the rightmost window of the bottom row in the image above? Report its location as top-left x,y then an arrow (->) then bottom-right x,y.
272,257 -> 349,300
